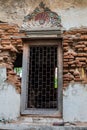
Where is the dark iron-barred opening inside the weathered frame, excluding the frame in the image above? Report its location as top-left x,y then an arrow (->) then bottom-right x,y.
27,45 -> 58,109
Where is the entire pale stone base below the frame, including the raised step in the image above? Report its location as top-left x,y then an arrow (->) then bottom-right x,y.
0,117 -> 87,130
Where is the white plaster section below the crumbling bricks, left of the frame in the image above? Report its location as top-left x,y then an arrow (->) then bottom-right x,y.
0,68 -> 20,120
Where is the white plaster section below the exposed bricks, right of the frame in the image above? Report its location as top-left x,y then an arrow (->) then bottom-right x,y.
63,84 -> 87,122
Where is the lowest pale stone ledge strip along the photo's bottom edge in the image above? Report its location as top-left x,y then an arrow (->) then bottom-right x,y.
0,123 -> 87,130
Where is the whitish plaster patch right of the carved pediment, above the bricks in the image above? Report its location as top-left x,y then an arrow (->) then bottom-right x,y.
56,8 -> 87,30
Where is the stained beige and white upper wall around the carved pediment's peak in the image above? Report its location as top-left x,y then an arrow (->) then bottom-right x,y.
0,0 -> 87,29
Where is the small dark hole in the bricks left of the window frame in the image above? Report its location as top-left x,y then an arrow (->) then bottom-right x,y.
14,53 -> 23,77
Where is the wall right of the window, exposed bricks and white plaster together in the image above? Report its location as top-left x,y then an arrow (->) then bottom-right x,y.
63,28 -> 87,122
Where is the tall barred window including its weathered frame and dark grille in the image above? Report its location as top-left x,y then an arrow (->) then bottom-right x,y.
22,40 -> 62,115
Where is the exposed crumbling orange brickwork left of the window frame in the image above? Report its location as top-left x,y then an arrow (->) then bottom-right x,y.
0,23 -> 23,92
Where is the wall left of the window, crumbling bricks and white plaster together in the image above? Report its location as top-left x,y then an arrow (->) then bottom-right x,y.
0,23 -> 22,121
